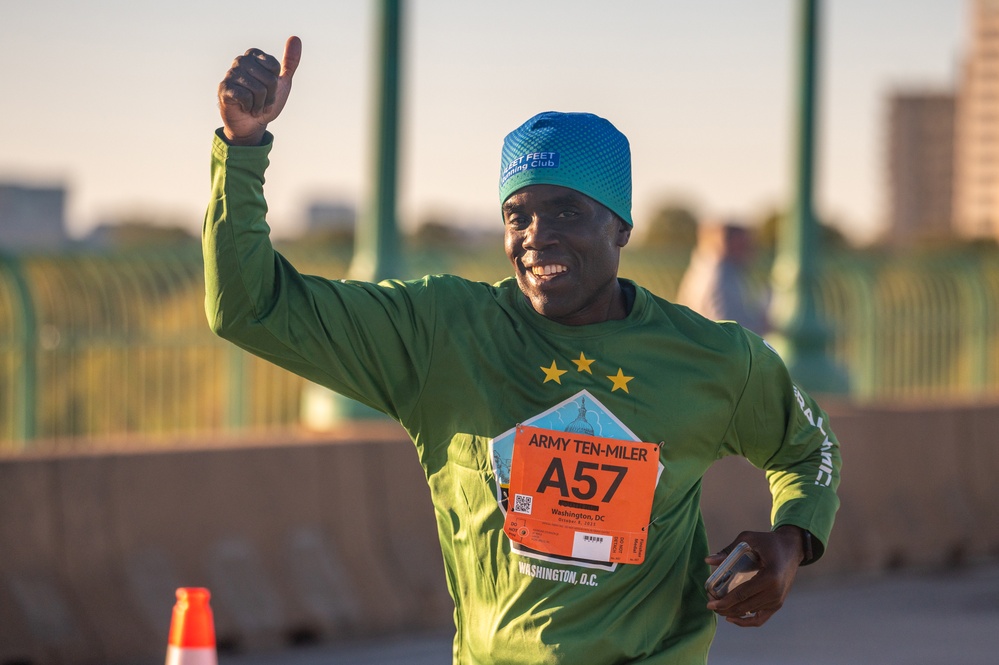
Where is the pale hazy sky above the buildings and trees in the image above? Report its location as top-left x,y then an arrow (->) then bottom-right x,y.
0,0 -> 968,242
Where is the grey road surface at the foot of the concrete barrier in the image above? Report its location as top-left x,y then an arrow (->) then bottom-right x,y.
219,563 -> 999,665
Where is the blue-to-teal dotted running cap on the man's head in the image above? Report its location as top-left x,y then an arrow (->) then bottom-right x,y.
500,111 -> 633,226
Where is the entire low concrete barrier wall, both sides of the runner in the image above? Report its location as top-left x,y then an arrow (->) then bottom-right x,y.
0,404 -> 999,665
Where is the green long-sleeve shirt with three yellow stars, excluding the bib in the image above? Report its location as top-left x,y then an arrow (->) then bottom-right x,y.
204,131 -> 840,665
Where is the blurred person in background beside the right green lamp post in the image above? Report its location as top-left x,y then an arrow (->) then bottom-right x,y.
676,218 -> 769,335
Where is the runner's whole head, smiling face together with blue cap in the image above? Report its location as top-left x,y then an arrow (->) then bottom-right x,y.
500,112 -> 632,325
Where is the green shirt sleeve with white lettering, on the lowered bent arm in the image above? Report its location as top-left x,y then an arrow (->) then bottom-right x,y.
723,332 -> 842,559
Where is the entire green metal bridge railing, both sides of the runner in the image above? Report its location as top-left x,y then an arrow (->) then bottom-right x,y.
0,246 -> 999,452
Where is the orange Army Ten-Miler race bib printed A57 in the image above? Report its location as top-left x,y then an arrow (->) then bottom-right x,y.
503,425 -> 659,563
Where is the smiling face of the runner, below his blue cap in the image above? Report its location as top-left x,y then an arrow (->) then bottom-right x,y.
503,185 -> 631,325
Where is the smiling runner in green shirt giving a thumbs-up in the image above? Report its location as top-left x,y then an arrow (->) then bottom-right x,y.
204,37 -> 839,664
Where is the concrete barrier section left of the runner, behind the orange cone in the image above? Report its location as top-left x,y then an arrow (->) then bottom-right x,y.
0,428 -> 453,664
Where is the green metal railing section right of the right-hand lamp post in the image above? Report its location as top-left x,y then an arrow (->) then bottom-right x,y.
820,253 -> 999,400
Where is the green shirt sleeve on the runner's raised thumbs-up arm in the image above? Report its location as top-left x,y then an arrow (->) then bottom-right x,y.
202,133 -> 434,420
